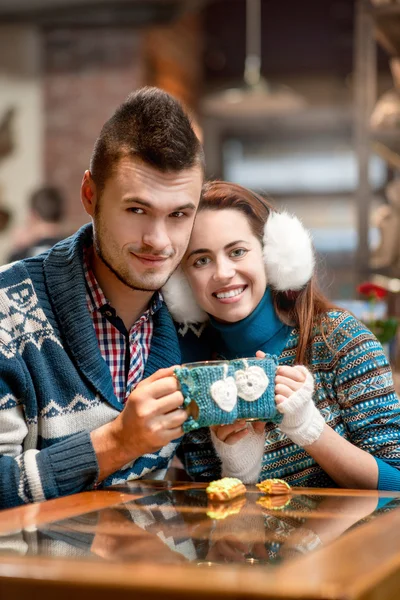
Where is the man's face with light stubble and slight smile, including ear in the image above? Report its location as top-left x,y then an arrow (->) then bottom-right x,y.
82,158 -> 203,292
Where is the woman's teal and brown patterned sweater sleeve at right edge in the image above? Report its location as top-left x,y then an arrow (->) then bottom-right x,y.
328,315 -> 400,490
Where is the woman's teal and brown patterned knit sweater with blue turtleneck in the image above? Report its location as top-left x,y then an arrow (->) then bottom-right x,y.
178,288 -> 400,490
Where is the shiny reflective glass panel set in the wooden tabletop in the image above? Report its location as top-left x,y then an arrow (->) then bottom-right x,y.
0,482 -> 400,569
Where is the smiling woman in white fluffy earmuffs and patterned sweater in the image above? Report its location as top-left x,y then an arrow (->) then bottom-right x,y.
164,181 -> 400,490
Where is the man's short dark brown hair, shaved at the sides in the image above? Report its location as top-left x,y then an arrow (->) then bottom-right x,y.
90,87 -> 204,194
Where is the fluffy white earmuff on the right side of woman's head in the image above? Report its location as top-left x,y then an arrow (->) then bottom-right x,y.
263,212 -> 315,292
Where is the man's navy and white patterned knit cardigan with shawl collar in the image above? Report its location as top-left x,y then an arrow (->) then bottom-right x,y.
0,226 -> 181,508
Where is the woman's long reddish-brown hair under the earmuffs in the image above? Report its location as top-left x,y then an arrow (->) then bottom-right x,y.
198,181 -> 337,364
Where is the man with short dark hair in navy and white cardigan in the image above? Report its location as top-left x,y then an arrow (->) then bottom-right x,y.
0,88 -> 204,508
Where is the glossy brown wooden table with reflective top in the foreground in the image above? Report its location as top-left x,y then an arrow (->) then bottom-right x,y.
0,481 -> 400,600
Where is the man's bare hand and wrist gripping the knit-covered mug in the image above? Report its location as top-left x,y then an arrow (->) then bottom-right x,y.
91,367 -> 187,481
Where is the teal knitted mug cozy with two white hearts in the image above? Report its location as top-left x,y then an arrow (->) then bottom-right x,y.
175,355 -> 282,432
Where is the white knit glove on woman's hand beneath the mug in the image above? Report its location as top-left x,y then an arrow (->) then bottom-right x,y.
210,423 -> 265,483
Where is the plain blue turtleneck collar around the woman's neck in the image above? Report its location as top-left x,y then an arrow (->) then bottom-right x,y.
210,287 -> 292,359
